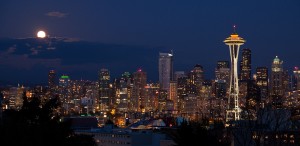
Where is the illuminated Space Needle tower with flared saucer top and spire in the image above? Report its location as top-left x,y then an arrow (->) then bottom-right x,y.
224,26 -> 245,121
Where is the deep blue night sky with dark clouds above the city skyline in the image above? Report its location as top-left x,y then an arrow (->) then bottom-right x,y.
0,0 -> 300,83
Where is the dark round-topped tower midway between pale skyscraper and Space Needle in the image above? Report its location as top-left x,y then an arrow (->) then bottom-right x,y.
189,64 -> 204,95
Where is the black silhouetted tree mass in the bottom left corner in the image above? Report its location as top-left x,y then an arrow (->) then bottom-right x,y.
0,93 -> 95,146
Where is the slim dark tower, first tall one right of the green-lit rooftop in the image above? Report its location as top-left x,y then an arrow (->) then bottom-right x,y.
99,68 -> 111,111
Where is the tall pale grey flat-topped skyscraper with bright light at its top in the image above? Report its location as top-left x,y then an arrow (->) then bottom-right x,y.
158,52 -> 173,91
